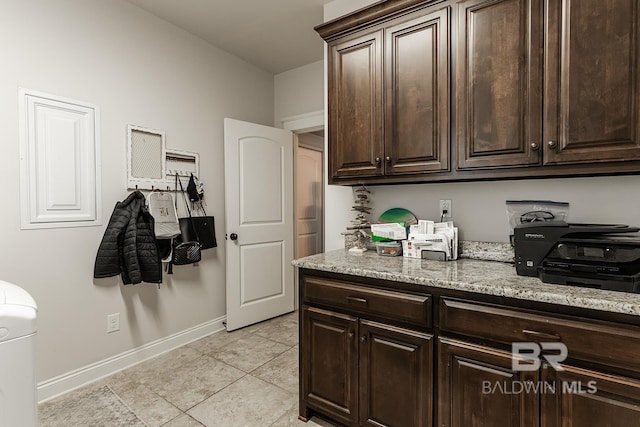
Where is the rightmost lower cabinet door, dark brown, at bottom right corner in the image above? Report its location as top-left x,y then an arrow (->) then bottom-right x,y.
542,365 -> 640,427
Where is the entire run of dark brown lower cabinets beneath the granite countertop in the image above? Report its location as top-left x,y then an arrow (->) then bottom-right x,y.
300,270 -> 640,427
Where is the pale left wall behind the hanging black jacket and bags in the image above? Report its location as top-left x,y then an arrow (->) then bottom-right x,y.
0,0 -> 274,381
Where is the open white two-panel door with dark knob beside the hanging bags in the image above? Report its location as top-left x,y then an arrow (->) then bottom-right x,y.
224,119 -> 295,331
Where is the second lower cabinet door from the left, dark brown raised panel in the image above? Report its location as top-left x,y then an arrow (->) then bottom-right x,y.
358,320 -> 433,427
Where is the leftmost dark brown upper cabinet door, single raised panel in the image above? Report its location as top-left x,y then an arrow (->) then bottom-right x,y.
328,30 -> 383,178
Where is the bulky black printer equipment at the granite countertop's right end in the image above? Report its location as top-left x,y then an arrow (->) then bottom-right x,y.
513,221 -> 640,293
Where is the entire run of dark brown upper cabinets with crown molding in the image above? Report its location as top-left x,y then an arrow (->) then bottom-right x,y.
316,0 -> 640,185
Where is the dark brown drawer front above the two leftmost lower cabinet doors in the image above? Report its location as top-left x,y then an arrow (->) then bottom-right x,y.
304,277 -> 433,327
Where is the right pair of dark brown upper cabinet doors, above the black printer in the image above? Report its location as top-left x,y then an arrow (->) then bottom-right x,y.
456,0 -> 640,169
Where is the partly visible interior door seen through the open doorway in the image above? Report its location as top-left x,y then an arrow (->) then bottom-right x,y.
296,146 -> 323,258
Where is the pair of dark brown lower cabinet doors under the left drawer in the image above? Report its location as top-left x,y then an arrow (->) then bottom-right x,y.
301,307 -> 433,427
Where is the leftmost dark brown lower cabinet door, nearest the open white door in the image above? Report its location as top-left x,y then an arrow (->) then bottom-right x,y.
301,307 -> 358,424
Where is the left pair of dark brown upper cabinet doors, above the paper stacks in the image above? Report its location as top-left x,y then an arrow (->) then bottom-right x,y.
328,3 -> 451,182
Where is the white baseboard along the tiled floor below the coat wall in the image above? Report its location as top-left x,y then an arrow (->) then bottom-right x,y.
38,316 -> 226,403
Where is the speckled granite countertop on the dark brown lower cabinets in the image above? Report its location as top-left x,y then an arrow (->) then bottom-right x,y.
293,249 -> 640,316
